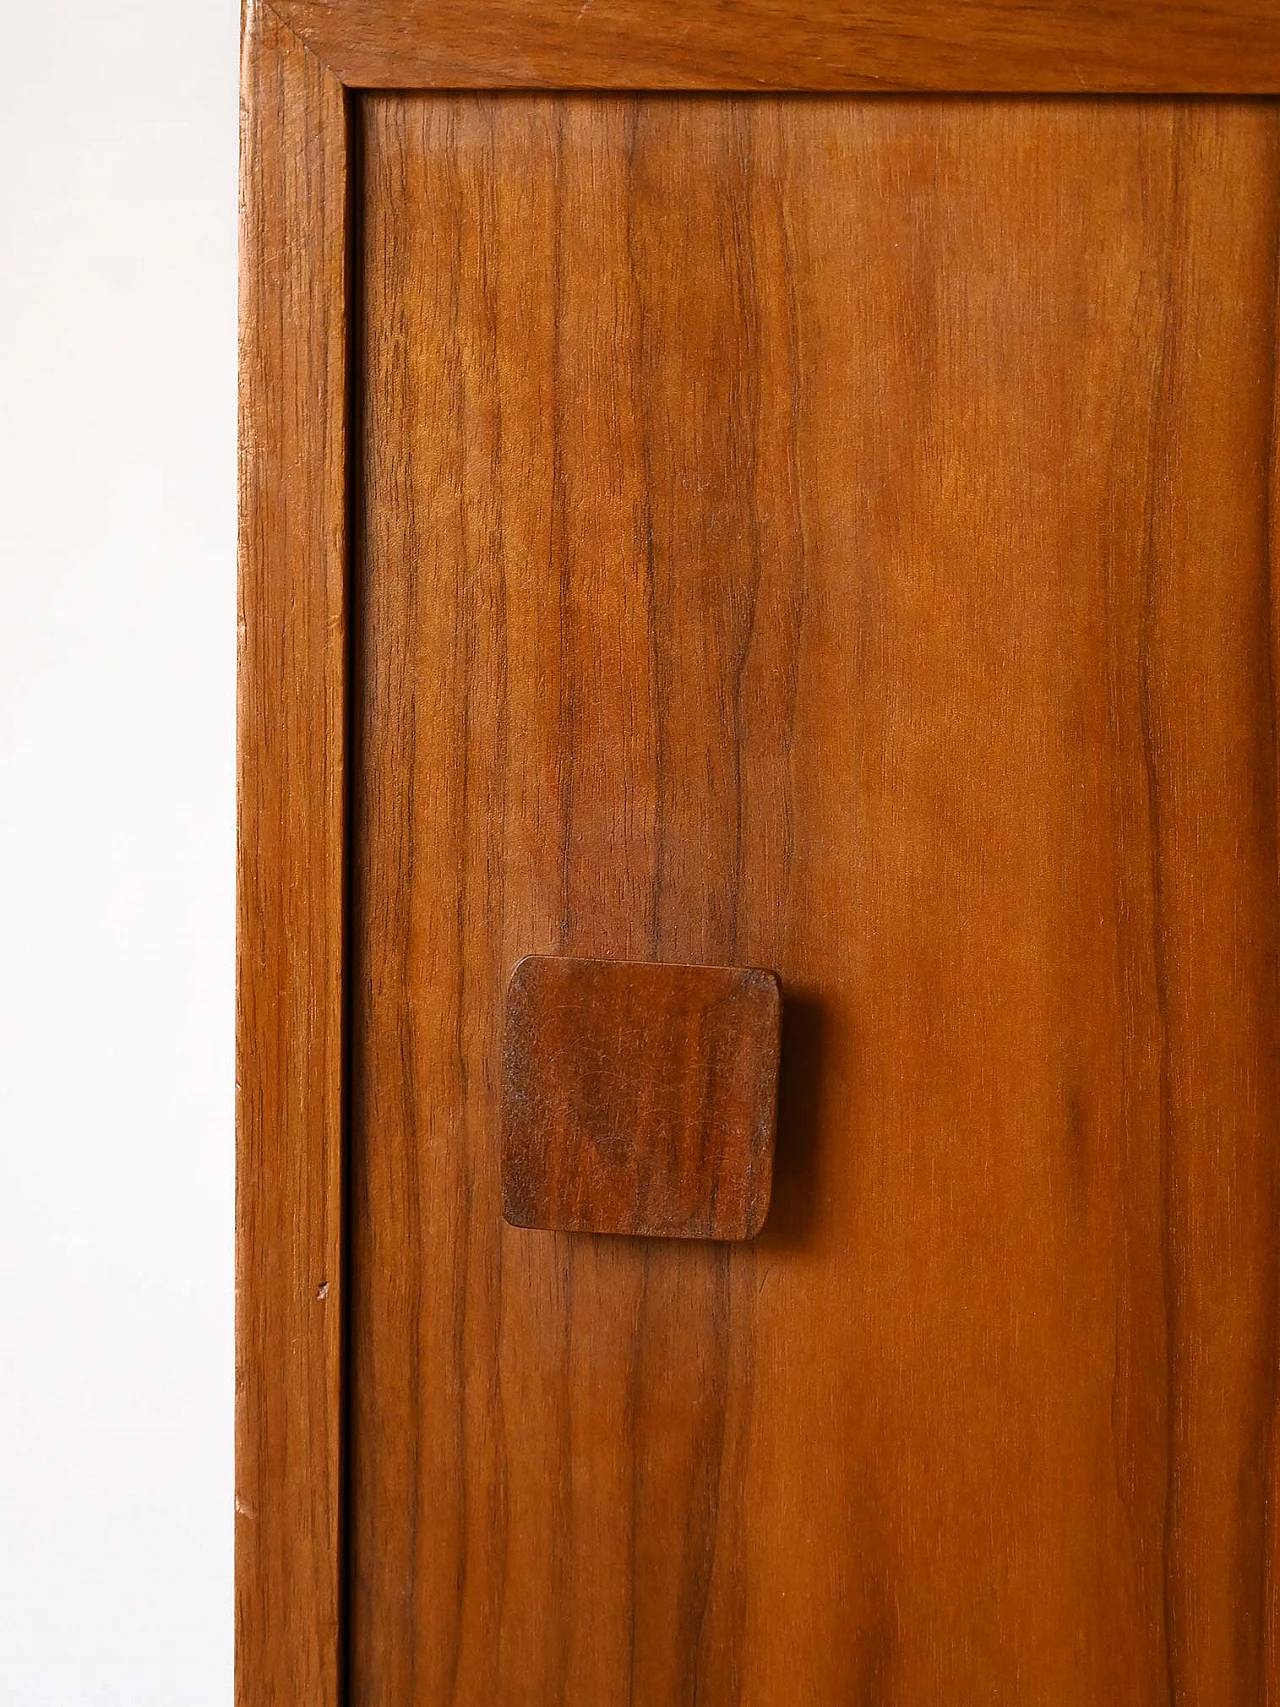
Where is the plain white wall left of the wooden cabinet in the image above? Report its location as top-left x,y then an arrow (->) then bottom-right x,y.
0,0 -> 239,1707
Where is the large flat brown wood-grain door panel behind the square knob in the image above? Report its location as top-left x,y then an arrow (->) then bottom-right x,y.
348,96 -> 1280,1707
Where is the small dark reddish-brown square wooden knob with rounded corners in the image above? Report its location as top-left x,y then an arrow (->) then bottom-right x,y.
502,954 -> 782,1239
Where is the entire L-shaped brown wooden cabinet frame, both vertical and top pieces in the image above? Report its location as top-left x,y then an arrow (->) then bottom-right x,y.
236,0 -> 1280,1707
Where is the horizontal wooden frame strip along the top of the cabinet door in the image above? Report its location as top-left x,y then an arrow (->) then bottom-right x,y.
275,0 -> 1280,94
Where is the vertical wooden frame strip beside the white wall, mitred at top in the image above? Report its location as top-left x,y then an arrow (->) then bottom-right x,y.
236,3 -> 346,1707
